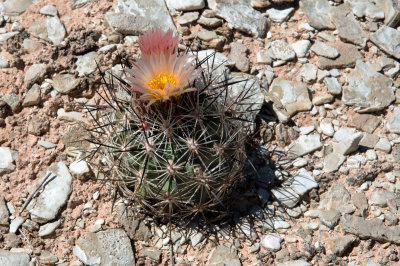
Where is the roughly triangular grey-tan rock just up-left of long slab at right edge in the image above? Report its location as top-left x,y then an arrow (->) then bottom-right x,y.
318,183 -> 355,214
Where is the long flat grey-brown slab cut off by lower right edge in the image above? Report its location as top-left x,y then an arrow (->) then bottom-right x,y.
340,214 -> 400,244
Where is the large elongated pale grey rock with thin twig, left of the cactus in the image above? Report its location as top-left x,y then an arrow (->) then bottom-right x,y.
27,162 -> 72,223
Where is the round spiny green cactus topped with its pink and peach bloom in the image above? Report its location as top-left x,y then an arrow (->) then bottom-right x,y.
87,30 -> 258,219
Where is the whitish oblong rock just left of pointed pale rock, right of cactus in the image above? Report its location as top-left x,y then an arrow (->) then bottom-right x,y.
288,134 -> 322,158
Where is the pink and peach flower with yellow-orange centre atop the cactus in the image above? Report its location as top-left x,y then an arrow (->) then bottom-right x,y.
127,29 -> 201,106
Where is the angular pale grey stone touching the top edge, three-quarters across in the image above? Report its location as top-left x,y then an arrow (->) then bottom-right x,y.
300,0 -> 334,30
